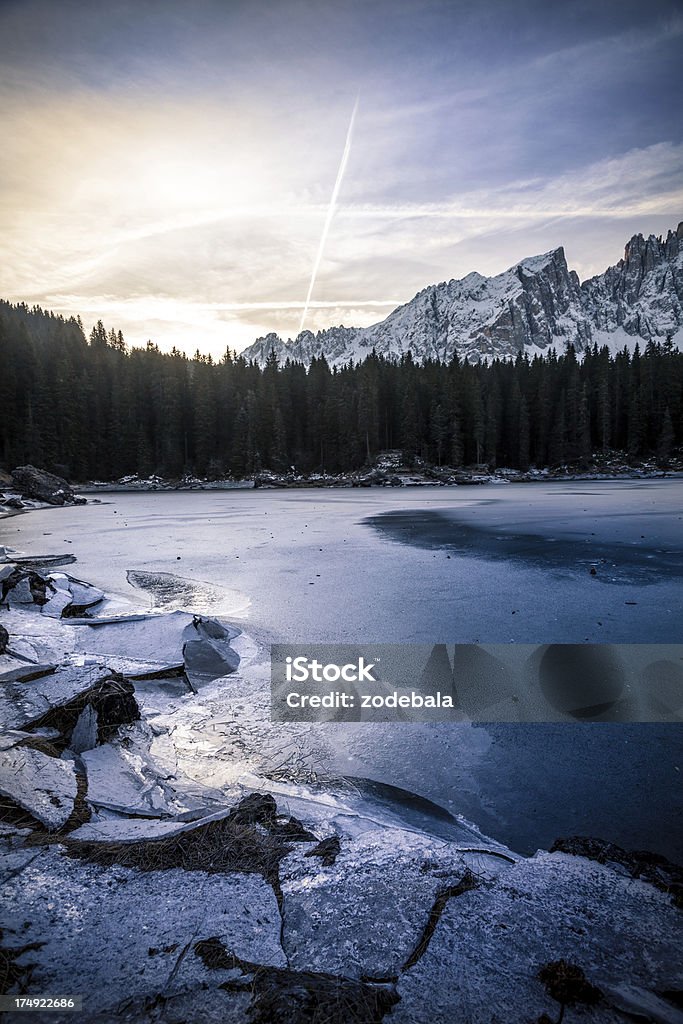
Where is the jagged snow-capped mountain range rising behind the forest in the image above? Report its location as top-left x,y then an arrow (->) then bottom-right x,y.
243,222 -> 683,366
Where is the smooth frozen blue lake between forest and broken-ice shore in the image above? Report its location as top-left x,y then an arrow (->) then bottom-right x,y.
0,480 -> 683,857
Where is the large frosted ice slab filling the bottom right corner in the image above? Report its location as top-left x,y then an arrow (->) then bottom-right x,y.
391,852 -> 681,1024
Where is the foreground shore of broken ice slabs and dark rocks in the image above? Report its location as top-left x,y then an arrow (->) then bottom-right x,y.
0,550 -> 683,1024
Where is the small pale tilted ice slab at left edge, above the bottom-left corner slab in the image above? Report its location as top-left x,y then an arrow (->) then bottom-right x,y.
0,744 -> 77,829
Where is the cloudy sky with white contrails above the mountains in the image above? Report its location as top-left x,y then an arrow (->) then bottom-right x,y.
0,0 -> 683,356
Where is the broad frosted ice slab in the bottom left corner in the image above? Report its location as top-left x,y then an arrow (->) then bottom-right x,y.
1,849 -> 285,1021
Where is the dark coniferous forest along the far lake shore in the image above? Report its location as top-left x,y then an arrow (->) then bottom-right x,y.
0,302 -> 683,481
